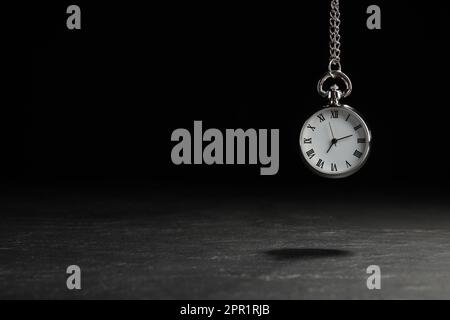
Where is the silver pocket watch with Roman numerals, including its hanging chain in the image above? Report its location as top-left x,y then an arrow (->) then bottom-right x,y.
300,0 -> 372,178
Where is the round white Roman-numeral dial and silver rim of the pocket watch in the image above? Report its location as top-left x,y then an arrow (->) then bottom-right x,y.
300,106 -> 371,178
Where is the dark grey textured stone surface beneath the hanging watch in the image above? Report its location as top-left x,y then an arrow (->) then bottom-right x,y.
0,190 -> 450,299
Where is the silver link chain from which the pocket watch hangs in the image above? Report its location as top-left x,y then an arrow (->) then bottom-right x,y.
329,0 -> 341,71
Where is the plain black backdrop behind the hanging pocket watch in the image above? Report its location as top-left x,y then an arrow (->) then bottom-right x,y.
25,1 -> 450,190
